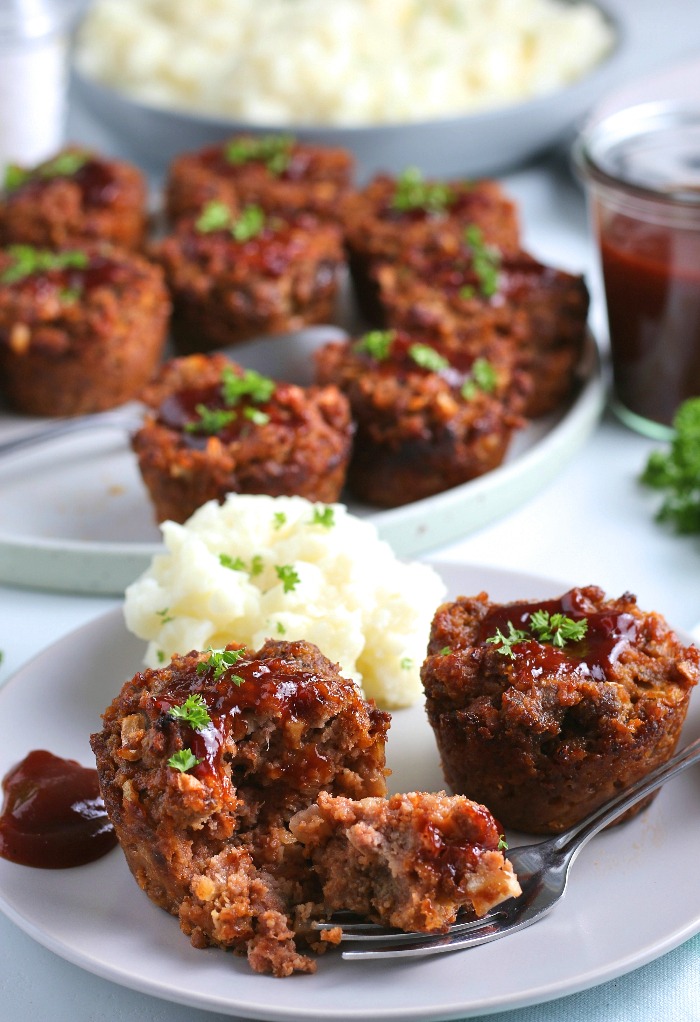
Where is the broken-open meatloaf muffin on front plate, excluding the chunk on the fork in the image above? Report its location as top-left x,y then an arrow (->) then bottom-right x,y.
91,641 -> 389,976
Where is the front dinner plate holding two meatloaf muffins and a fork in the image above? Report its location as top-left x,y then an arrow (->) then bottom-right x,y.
0,564 -> 700,1022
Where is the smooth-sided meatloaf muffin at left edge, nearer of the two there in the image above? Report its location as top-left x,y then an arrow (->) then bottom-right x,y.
0,245 -> 170,416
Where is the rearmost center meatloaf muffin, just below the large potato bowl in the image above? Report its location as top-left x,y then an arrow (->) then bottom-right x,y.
166,135 -> 355,221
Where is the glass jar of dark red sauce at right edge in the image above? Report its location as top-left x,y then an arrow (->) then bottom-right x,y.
573,102 -> 700,438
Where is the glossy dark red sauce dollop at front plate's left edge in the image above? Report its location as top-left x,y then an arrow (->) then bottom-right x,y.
0,749 -> 116,870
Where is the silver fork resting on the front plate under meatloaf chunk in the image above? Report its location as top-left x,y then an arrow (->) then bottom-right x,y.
314,738 -> 700,961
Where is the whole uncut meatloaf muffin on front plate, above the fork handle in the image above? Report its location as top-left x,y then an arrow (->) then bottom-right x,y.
422,586 -> 700,834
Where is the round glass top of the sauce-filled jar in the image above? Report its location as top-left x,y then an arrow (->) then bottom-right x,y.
573,102 -> 700,204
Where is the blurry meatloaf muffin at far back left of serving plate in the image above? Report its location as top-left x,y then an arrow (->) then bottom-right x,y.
0,147 -> 147,248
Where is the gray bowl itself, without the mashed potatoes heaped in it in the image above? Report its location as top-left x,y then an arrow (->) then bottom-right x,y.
68,3 -> 623,182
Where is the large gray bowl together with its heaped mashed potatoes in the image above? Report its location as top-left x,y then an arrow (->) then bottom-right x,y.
69,0 -> 620,179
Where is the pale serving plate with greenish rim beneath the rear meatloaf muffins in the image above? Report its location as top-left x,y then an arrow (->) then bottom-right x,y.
0,326 -> 605,595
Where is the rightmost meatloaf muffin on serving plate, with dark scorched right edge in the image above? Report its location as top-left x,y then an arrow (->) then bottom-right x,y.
372,245 -> 589,418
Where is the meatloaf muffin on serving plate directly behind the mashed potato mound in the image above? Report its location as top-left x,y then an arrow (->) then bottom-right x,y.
132,353 -> 353,521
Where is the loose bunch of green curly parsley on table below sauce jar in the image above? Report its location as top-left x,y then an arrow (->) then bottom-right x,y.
641,398 -> 700,535
